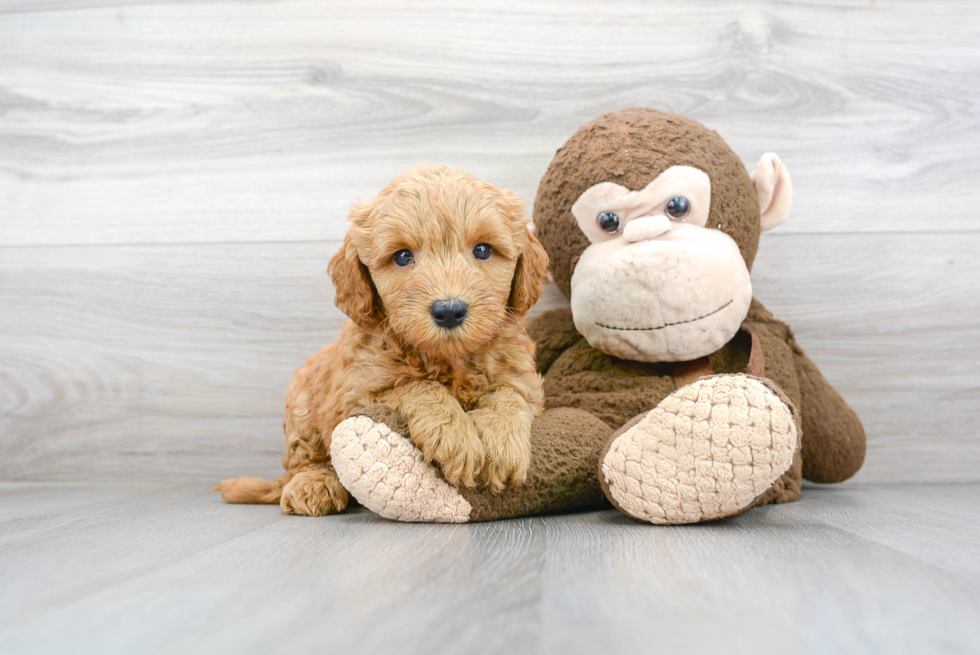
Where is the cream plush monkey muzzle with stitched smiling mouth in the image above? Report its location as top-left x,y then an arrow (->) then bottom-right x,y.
571,226 -> 752,362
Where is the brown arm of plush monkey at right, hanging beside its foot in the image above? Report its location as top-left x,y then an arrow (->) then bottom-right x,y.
789,335 -> 865,483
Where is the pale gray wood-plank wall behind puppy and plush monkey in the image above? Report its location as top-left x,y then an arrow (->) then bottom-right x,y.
0,0 -> 980,483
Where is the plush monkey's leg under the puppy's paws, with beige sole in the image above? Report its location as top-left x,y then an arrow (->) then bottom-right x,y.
331,405 -> 612,523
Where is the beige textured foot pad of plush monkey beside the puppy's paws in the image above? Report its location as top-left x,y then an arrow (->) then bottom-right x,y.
330,416 -> 472,523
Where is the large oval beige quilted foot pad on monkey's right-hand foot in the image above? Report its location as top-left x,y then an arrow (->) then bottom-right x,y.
600,375 -> 799,524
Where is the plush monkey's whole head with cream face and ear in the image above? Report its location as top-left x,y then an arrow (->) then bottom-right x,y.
534,108 -> 792,362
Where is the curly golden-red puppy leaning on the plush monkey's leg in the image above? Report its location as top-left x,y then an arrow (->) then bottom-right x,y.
215,165 -> 548,516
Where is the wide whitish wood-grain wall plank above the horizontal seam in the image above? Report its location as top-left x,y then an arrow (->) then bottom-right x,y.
0,0 -> 980,244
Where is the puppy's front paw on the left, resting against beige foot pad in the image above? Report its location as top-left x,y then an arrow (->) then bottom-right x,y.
411,414 -> 486,487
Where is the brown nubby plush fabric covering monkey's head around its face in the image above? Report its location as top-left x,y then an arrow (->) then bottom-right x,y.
534,107 -> 761,298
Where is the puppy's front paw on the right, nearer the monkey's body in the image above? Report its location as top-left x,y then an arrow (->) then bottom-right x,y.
469,409 -> 531,494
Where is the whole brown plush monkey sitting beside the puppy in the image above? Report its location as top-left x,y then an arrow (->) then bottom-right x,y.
332,108 -> 865,524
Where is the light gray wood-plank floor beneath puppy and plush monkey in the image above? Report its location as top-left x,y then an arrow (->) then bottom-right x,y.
0,482 -> 980,655
